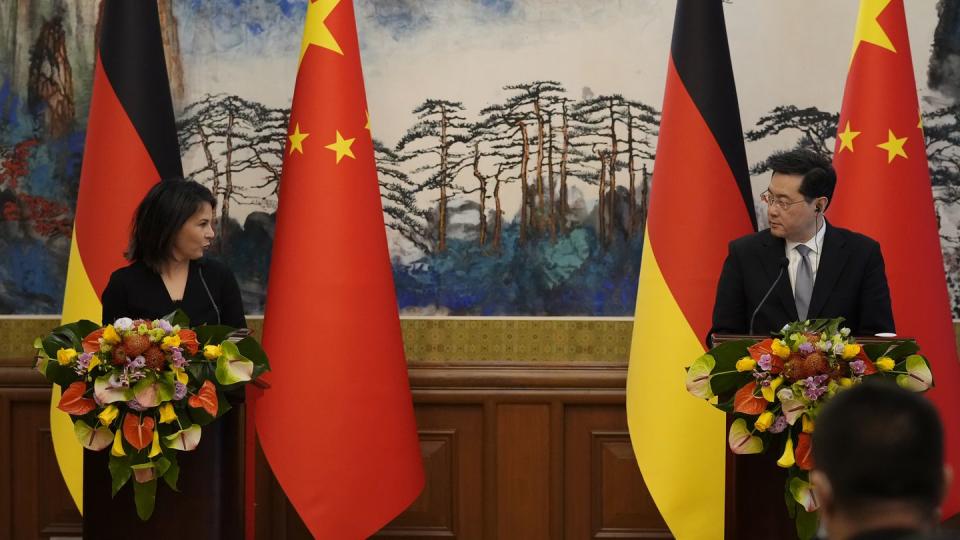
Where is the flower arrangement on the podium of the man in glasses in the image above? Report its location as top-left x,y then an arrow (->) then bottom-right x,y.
686,318 -> 933,539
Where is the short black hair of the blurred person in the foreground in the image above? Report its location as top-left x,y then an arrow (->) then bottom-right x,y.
813,381 -> 944,516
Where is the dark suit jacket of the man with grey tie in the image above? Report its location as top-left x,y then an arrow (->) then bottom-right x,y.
707,225 -> 894,343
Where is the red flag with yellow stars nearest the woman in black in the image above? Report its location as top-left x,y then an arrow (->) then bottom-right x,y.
256,0 -> 424,538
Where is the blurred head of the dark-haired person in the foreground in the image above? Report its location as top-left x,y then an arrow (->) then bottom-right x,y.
810,381 -> 951,540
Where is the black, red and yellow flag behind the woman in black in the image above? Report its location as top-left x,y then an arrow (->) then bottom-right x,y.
50,0 -> 183,513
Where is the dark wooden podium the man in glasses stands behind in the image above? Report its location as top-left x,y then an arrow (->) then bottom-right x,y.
712,334 -> 909,540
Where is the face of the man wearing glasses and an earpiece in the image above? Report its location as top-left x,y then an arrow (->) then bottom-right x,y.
767,173 -> 817,242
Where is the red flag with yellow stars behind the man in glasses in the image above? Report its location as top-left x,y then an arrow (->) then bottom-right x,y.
827,0 -> 960,518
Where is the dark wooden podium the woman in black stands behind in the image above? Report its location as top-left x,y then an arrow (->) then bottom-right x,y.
83,402 -> 245,540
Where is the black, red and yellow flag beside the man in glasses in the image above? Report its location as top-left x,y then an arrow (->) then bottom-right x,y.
627,0 -> 756,540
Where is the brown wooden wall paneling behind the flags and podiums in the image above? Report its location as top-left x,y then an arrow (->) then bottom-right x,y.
0,362 -> 671,540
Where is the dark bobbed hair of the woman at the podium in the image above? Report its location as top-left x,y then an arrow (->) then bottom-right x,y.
125,178 -> 217,272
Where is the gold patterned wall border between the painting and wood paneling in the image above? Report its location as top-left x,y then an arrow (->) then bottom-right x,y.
0,317 -> 960,365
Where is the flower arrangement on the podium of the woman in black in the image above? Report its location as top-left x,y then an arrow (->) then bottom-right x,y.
34,311 -> 270,520
